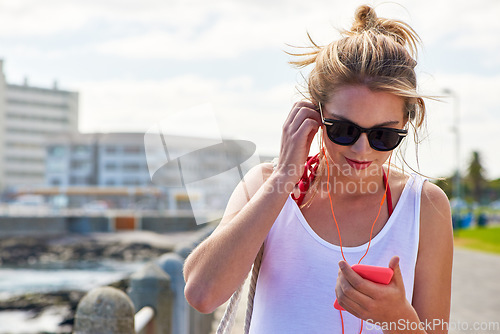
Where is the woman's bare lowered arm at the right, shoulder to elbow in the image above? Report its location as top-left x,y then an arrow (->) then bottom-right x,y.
412,182 -> 453,333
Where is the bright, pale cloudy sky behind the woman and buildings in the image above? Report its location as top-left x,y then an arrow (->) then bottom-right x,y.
0,0 -> 500,179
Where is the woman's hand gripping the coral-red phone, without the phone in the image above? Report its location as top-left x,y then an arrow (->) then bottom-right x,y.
335,256 -> 416,324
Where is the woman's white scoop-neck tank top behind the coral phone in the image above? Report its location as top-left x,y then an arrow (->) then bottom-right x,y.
250,174 -> 425,334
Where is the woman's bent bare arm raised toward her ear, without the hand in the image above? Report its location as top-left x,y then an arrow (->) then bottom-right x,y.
184,164 -> 288,313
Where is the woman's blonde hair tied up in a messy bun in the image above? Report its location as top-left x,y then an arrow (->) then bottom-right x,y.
289,5 -> 425,204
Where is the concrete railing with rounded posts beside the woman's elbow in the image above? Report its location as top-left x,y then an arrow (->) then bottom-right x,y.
73,227 -> 213,334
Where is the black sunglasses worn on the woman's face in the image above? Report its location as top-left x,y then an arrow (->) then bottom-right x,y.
319,105 -> 408,151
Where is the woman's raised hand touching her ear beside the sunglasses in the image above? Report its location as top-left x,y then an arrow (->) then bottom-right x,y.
277,101 -> 322,184
